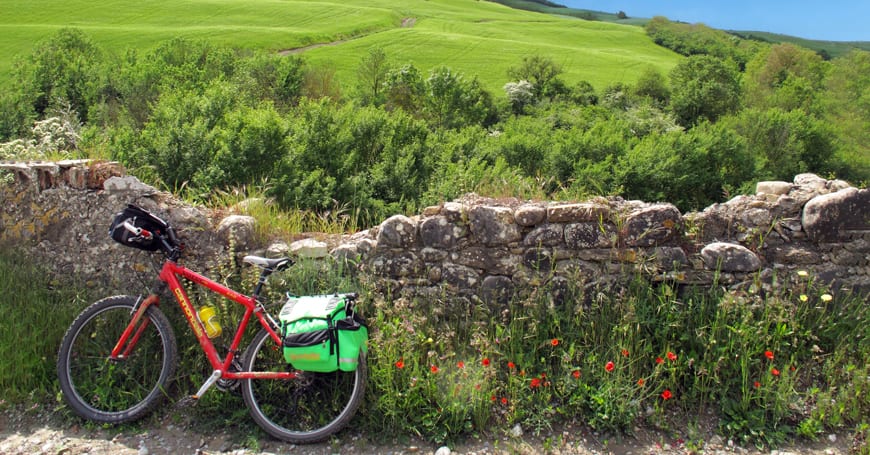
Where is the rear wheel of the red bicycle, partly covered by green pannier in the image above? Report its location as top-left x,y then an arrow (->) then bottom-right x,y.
242,329 -> 367,444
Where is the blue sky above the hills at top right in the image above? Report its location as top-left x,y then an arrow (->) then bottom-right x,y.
551,0 -> 870,41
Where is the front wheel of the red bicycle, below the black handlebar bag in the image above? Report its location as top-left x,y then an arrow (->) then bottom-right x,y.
57,296 -> 177,423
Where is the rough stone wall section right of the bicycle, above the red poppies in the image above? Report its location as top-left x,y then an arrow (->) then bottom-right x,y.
335,174 -> 870,300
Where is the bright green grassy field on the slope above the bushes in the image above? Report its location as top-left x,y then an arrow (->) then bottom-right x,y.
0,0 -> 680,92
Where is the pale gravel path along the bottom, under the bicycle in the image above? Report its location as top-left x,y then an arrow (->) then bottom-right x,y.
0,405 -> 853,455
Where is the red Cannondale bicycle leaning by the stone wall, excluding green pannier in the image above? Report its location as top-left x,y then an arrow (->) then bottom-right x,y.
57,204 -> 367,444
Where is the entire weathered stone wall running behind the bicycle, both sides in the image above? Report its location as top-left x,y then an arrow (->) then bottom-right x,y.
0,161 -> 870,301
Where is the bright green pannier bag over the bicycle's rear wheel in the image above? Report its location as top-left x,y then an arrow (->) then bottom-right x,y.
278,294 -> 369,373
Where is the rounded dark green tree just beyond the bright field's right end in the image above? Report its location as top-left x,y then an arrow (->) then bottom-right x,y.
670,55 -> 741,127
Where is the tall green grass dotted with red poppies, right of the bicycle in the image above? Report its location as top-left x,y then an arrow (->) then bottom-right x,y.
369,270 -> 870,446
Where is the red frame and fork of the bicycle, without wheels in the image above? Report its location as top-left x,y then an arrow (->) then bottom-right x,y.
111,260 -> 296,386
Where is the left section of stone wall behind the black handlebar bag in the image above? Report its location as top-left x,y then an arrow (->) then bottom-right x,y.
0,160 -> 226,294
